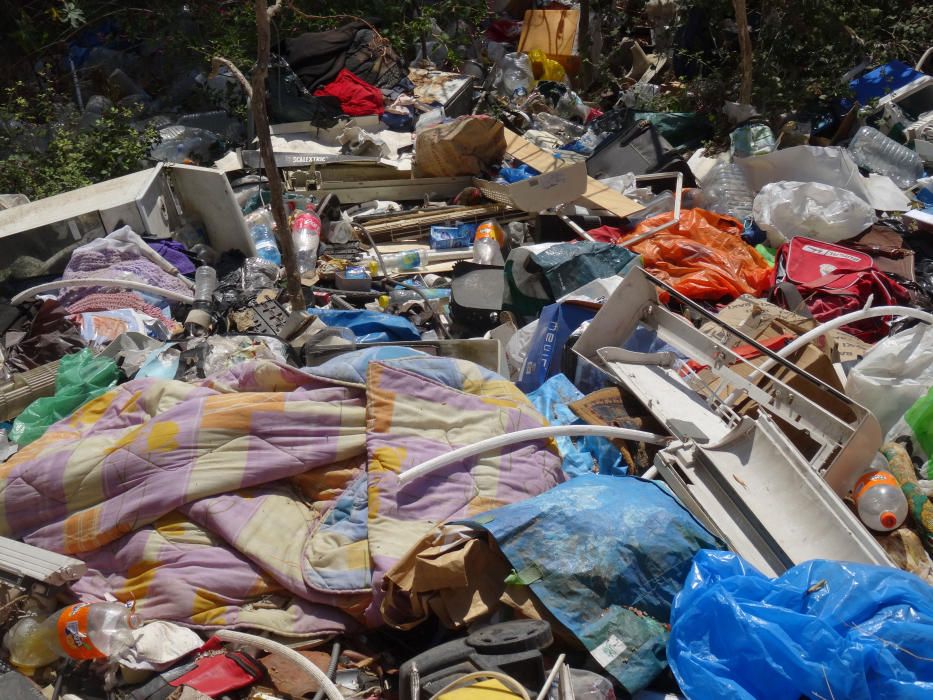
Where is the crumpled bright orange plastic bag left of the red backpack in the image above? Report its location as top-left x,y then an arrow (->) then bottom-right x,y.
615,209 -> 771,301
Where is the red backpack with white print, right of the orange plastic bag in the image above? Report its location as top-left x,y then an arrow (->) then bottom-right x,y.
771,236 -> 910,343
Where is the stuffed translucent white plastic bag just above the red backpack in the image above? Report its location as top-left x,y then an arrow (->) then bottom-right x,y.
752,181 -> 875,248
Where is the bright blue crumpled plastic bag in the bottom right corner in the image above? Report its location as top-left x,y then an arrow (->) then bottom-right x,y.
667,551 -> 933,700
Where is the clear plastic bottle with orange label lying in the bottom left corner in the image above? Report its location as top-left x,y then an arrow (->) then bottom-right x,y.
3,603 -> 142,670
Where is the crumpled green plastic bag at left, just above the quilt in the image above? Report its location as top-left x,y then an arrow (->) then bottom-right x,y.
10,348 -> 119,447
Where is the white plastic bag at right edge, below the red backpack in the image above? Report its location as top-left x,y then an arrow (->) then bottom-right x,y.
846,323 -> 933,433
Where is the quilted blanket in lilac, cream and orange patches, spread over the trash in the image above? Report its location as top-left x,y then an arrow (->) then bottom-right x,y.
0,355 -> 564,636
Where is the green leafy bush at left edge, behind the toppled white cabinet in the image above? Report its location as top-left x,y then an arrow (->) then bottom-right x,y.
0,82 -> 158,199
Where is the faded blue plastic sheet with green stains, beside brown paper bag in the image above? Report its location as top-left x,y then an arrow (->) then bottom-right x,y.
470,474 -> 719,693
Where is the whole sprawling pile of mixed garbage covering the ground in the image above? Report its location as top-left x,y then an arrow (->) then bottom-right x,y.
0,8 -> 933,700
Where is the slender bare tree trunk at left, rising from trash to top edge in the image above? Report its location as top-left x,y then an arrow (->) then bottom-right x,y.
251,0 -> 305,311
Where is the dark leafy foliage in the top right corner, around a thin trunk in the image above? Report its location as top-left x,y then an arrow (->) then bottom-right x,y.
679,0 -> 933,116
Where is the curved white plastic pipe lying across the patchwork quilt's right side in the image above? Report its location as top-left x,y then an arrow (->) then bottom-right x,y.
398,425 -> 670,486
